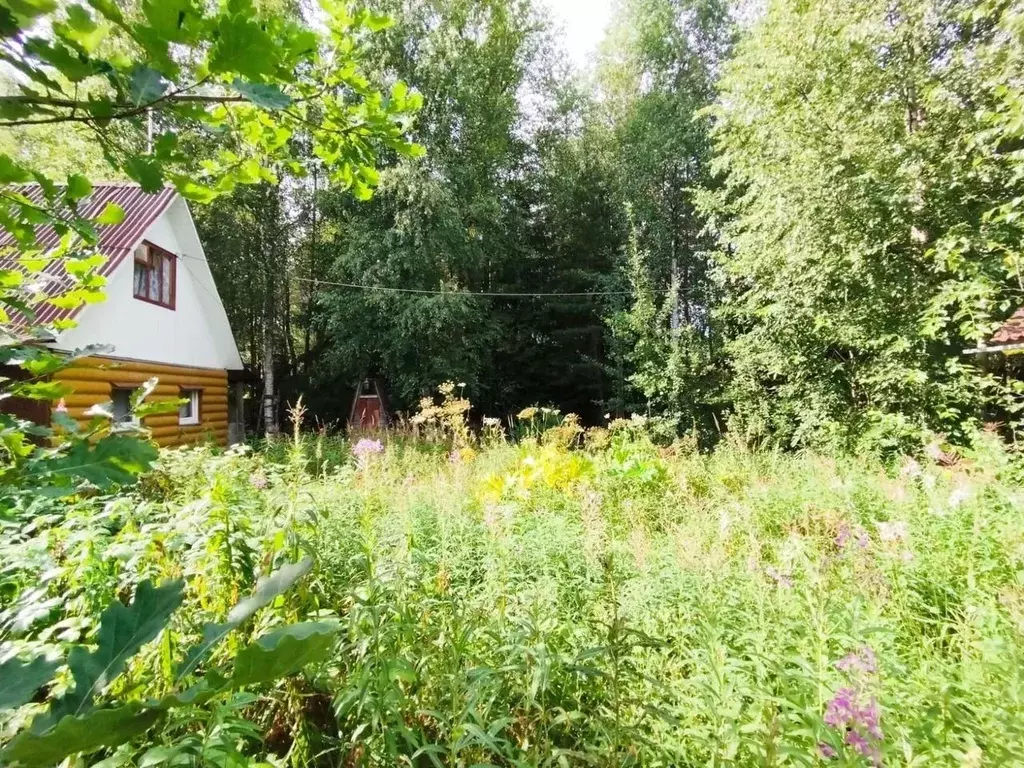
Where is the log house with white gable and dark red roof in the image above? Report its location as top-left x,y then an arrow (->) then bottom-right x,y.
0,183 -> 242,445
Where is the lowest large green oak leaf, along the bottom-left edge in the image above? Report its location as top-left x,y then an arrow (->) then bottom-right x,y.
0,701 -> 164,766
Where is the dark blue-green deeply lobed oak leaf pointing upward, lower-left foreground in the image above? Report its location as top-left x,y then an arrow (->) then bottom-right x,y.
44,580 -> 184,724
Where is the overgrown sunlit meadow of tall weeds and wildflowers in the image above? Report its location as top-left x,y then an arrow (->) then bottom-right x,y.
0,397 -> 1024,768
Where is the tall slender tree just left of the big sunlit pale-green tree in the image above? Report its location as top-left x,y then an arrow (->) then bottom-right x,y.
598,0 -> 732,436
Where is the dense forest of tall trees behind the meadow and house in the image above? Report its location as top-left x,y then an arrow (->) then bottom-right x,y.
7,0 -> 1024,447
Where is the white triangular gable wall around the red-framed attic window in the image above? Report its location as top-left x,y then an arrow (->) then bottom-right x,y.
56,198 -> 242,370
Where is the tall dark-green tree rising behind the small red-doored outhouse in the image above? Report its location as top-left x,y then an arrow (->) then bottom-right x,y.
317,0 -> 537,413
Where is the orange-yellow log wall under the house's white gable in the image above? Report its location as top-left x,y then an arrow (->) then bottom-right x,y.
53,356 -> 228,447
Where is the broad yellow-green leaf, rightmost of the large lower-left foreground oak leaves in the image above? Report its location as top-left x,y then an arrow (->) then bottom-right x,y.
229,622 -> 340,687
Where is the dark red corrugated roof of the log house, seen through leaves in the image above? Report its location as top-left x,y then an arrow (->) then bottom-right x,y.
0,181 -> 177,324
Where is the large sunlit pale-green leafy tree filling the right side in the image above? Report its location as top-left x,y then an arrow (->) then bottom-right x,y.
713,0 -> 1021,447
